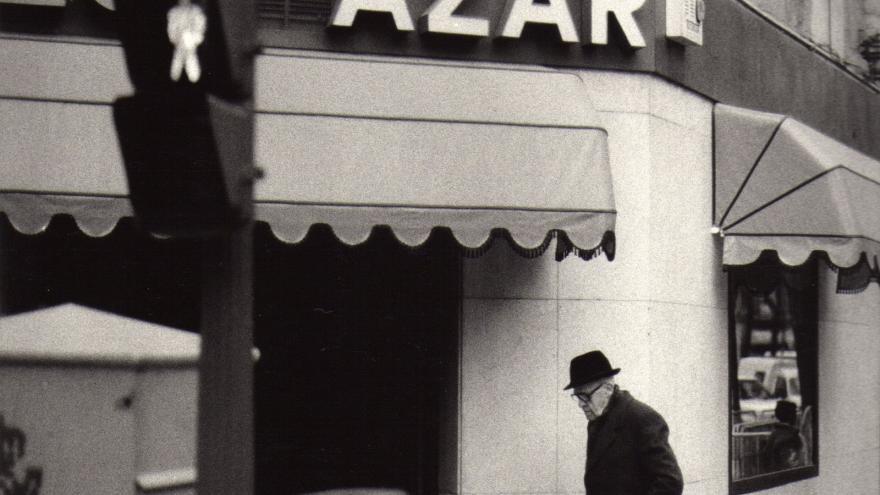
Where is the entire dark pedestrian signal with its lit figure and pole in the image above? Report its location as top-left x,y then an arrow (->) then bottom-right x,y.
113,0 -> 258,495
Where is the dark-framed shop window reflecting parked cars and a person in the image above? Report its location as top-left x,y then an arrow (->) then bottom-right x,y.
728,255 -> 819,493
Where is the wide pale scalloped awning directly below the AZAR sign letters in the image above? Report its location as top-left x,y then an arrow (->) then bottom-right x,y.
256,52 -> 615,257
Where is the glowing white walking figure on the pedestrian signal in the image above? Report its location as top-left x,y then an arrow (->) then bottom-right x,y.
168,0 -> 208,82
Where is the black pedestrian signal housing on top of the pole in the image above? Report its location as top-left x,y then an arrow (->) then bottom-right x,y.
113,0 -> 256,237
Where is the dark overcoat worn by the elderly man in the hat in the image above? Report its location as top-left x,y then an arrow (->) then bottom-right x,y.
584,388 -> 683,495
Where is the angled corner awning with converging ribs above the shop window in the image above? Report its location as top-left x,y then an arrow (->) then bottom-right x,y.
715,105 -> 880,276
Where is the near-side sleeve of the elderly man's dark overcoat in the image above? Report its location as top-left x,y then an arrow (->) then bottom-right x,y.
639,411 -> 684,495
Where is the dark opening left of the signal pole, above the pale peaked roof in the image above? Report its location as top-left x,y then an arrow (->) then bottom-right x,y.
0,215 -> 201,331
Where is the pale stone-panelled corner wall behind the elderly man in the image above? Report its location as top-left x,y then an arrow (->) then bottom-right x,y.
454,71 -> 880,495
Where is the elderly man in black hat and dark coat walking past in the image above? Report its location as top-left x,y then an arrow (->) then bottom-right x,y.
565,351 -> 683,495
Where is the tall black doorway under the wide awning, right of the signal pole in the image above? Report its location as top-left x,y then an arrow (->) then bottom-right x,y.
255,225 -> 460,495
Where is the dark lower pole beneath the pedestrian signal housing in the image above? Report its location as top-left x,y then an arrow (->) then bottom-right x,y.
197,224 -> 254,495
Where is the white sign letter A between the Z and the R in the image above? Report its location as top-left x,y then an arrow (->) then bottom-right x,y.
497,0 -> 580,43
